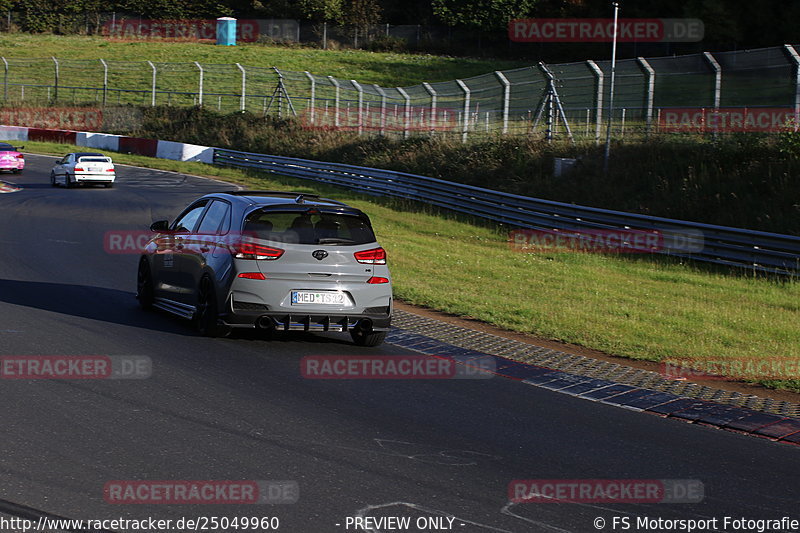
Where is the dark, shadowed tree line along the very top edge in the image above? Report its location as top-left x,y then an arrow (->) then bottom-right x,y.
0,0 -> 800,48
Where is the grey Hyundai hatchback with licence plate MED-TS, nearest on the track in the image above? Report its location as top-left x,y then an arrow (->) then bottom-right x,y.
137,191 -> 392,346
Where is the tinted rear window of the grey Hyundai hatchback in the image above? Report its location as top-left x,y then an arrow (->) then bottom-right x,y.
243,211 -> 375,246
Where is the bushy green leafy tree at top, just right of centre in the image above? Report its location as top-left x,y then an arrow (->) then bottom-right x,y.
433,0 -> 536,31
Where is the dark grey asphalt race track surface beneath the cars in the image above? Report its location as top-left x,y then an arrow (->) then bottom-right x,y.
0,156 -> 800,533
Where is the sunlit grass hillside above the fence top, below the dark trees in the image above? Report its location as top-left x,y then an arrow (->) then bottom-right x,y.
0,33 -> 531,87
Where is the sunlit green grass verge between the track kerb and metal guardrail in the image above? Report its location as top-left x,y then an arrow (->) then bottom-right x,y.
17,142 -> 800,392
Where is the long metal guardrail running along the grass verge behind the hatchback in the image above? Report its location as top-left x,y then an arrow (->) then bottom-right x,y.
214,149 -> 800,276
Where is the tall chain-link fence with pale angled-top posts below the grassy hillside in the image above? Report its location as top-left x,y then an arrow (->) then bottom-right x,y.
2,45 -> 800,141
